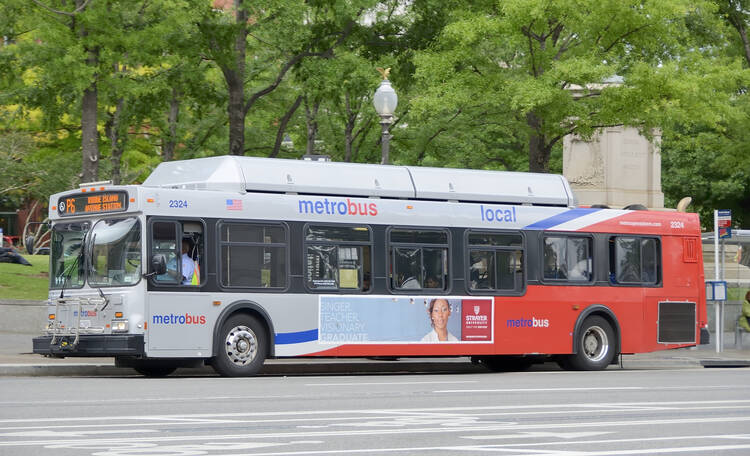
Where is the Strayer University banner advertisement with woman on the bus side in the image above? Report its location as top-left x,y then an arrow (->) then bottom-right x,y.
318,295 -> 493,344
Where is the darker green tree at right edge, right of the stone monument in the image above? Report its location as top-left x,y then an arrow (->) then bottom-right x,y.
662,0 -> 750,230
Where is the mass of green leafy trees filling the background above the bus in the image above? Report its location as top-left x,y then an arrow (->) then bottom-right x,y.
0,0 -> 750,228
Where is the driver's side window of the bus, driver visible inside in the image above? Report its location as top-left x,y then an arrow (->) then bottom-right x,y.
151,222 -> 203,286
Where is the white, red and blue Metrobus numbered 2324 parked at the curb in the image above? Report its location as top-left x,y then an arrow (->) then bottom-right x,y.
33,156 -> 708,376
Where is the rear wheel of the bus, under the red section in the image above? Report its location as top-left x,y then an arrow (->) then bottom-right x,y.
559,316 -> 615,370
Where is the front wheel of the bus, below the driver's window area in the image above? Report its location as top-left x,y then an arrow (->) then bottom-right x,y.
212,314 -> 268,377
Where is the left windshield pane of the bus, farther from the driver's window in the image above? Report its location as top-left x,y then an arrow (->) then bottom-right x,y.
50,222 -> 90,288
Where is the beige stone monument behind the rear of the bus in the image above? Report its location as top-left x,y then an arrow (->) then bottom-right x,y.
563,127 -> 664,209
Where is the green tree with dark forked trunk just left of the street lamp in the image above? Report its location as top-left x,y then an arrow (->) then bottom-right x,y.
201,0 -> 372,155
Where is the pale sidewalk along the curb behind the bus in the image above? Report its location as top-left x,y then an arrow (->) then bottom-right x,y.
0,333 -> 750,376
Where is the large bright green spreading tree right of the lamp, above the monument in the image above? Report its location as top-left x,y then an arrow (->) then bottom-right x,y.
414,0 -> 742,172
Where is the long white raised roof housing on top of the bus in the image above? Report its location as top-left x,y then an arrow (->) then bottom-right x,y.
143,156 -> 576,207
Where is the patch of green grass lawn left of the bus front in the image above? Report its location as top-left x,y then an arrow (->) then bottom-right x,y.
0,255 -> 49,301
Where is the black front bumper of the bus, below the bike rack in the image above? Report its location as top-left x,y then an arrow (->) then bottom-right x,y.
33,334 -> 144,357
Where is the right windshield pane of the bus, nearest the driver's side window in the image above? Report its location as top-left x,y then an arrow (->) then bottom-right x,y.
88,217 -> 141,287
